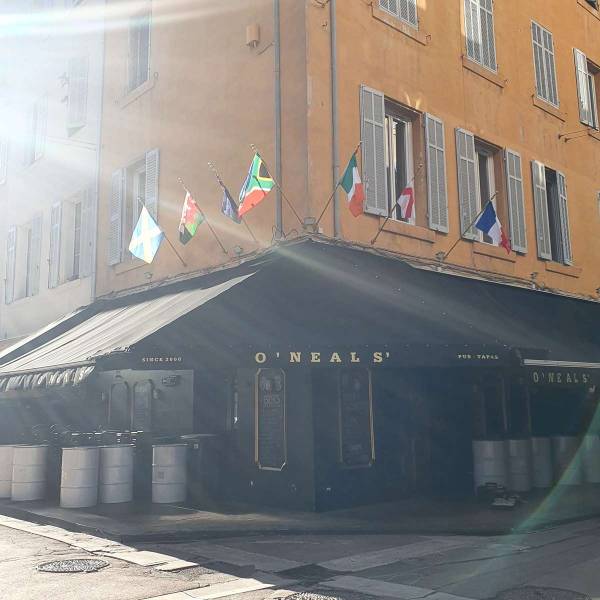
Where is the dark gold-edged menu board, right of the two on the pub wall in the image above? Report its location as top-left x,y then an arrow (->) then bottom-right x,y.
339,369 -> 374,467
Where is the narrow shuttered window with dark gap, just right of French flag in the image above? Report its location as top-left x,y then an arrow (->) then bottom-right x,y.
532,161 -> 573,265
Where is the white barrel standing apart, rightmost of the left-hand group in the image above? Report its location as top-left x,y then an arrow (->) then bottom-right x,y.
152,444 -> 187,504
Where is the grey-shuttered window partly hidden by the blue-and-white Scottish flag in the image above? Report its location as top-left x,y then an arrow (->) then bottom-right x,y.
108,149 -> 159,265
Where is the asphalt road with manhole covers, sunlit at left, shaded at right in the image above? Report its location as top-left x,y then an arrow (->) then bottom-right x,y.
0,520 -> 600,600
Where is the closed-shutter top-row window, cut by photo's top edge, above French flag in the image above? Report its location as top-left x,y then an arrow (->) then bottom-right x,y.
465,0 -> 497,71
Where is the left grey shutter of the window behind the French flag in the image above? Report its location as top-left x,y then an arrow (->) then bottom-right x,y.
456,129 -> 479,240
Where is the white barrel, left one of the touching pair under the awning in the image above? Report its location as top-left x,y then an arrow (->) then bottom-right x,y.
60,446 -> 100,508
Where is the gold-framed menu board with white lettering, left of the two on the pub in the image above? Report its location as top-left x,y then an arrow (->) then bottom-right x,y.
255,369 -> 287,471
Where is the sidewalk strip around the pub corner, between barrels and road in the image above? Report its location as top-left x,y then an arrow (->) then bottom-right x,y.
0,485 -> 600,543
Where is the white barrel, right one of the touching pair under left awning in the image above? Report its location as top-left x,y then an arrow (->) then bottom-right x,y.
99,444 -> 133,504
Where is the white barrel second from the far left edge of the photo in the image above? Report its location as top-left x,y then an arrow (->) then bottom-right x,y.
10,444 -> 48,502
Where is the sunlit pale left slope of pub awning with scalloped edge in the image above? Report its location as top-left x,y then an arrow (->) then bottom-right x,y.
0,275 -> 252,392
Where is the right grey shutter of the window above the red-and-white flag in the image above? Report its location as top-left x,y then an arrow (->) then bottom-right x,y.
425,115 -> 448,233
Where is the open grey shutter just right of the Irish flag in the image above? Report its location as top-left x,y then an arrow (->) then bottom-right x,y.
361,86 -> 388,217
